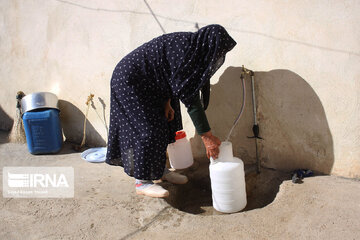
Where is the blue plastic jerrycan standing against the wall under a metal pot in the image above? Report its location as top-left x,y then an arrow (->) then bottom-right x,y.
22,109 -> 63,154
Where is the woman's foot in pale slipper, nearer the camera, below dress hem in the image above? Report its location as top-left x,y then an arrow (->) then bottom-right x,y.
135,179 -> 169,198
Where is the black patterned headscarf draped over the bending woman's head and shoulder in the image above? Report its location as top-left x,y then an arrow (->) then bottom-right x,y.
170,24 -> 236,108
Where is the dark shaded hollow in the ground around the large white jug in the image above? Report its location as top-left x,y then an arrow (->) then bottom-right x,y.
160,163 -> 291,215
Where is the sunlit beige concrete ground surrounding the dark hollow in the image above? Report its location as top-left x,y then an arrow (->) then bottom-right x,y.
0,133 -> 360,240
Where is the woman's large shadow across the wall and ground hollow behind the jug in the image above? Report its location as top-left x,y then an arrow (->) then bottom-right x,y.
162,67 -> 334,215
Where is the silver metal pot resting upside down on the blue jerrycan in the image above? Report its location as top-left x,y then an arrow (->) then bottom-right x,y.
21,92 -> 59,114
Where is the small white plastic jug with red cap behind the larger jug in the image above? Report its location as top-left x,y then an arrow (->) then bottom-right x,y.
167,131 -> 194,169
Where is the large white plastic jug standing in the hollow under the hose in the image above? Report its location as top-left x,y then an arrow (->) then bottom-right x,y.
209,142 -> 247,213
